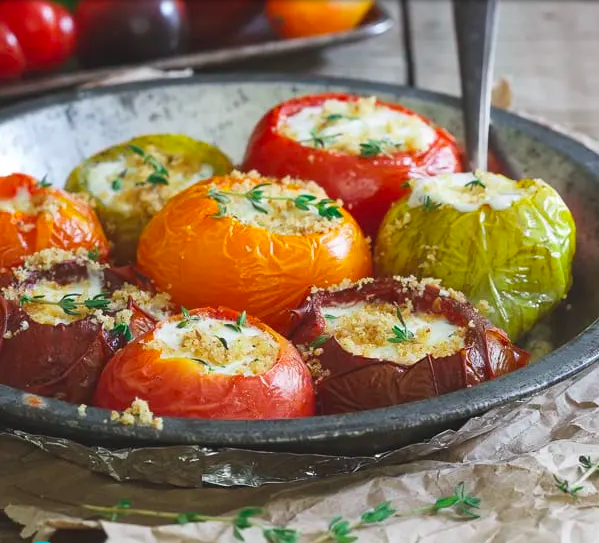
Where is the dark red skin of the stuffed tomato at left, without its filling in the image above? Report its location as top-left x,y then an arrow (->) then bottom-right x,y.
0,261 -> 164,404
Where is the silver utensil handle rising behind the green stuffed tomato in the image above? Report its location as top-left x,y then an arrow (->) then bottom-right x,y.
453,0 -> 497,171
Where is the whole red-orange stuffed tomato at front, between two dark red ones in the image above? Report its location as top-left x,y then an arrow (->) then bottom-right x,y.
94,308 -> 314,419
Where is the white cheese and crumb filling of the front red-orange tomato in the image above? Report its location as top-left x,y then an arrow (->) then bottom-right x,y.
152,315 -> 279,376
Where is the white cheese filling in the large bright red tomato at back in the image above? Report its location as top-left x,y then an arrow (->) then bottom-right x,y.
278,97 -> 437,155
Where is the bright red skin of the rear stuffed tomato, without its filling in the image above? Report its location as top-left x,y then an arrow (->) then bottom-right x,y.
241,93 -> 462,240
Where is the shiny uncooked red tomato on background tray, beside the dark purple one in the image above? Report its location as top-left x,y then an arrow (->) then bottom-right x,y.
0,0 -> 75,71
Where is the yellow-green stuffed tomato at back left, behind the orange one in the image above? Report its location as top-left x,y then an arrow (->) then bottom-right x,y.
66,134 -> 233,264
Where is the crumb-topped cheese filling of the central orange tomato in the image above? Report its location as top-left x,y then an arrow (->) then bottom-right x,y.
214,172 -> 340,235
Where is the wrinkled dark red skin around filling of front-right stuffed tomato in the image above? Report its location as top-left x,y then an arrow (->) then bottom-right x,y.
289,278 -> 530,415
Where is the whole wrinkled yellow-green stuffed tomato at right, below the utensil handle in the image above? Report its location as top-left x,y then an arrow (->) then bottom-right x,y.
375,172 -> 576,341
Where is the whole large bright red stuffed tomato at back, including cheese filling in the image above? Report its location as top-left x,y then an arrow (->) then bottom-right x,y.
242,94 -> 462,239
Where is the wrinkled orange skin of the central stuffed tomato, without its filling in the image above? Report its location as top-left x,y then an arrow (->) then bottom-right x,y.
137,176 -> 372,335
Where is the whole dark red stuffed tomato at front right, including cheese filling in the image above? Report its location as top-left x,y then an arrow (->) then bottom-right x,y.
290,277 -> 530,414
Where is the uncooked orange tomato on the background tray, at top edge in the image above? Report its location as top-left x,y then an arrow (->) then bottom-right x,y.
266,0 -> 374,38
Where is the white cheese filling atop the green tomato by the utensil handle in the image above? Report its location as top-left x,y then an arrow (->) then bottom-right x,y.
408,172 -> 537,213
